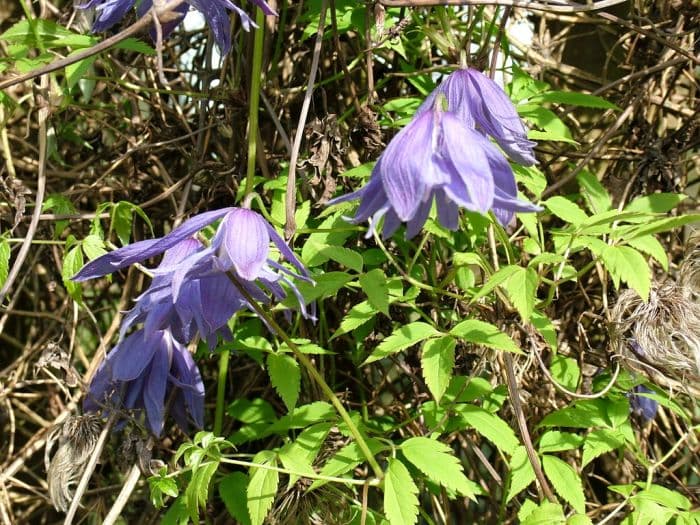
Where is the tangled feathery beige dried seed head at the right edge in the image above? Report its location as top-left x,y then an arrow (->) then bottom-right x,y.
610,241 -> 700,398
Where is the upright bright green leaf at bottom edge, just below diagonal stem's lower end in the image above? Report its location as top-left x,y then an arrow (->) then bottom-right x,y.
384,458 -> 418,525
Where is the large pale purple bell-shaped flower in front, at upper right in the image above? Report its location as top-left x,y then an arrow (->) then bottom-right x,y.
328,103 -> 540,239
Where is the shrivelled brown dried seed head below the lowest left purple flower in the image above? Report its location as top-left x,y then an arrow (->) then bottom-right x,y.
45,415 -> 102,512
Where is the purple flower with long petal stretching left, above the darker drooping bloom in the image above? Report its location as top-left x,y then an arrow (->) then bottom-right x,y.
73,208 -> 315,326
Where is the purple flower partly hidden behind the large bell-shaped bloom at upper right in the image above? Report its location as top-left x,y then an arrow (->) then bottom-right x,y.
416,68 -> 537,166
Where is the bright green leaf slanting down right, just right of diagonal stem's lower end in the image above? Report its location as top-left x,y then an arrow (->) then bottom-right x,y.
401,437 -> 478,500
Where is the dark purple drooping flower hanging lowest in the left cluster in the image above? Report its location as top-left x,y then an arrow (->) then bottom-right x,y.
83,330 -> 204,435
